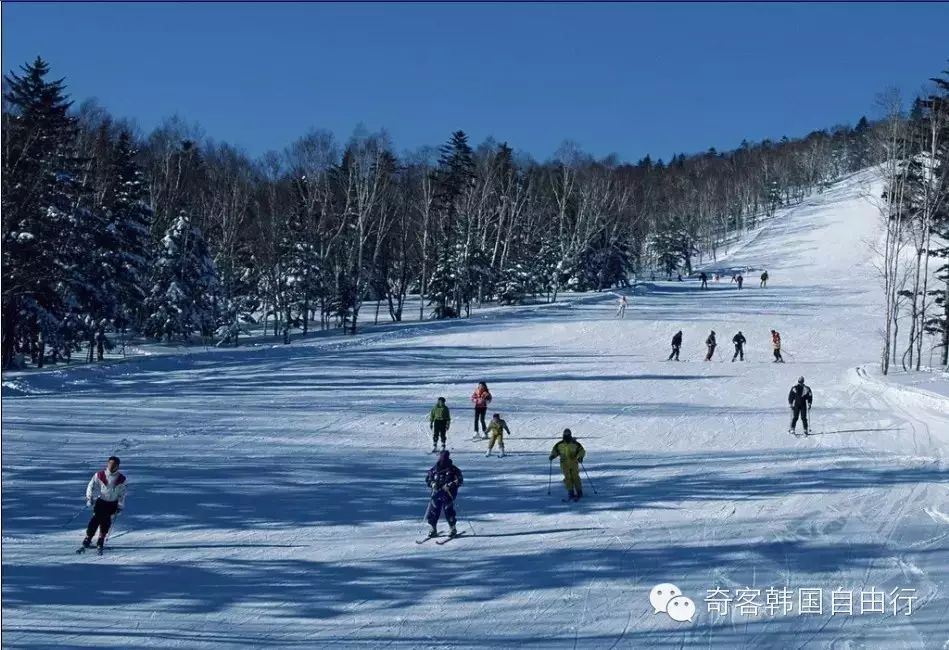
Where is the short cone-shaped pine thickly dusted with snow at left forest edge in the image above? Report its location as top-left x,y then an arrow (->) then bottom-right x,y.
144,212 -> 218,342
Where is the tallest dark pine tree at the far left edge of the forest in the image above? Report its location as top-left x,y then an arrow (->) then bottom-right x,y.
2,58 -> 92,368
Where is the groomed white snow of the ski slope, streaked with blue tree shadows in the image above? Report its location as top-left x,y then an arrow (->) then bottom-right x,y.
2,174 -> 949,649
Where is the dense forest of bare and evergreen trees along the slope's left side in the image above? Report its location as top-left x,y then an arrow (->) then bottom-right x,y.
2,58 -> 932,368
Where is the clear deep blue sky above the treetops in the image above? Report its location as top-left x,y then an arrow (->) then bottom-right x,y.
2,2 -> 949,161
